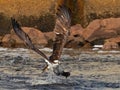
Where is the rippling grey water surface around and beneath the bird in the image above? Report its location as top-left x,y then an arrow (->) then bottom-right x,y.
0,48 -> 120,90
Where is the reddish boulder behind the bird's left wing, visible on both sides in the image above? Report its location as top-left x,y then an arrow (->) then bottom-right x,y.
2,27 -> 47,47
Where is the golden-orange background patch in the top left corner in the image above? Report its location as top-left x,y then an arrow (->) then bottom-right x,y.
0,0 -> 54,16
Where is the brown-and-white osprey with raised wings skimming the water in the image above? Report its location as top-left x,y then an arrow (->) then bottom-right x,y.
11,5 -> 71,78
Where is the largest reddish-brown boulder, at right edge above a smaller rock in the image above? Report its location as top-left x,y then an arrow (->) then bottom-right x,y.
82,18 -> 120,42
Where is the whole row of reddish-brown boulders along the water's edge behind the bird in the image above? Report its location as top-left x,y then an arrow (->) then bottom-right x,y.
2,18 -> 120,49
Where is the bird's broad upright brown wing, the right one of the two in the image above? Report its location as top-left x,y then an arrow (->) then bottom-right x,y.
50,6 -> 71,62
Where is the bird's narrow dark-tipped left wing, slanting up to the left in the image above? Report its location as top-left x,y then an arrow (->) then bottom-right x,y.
11,18 -> 48,60
